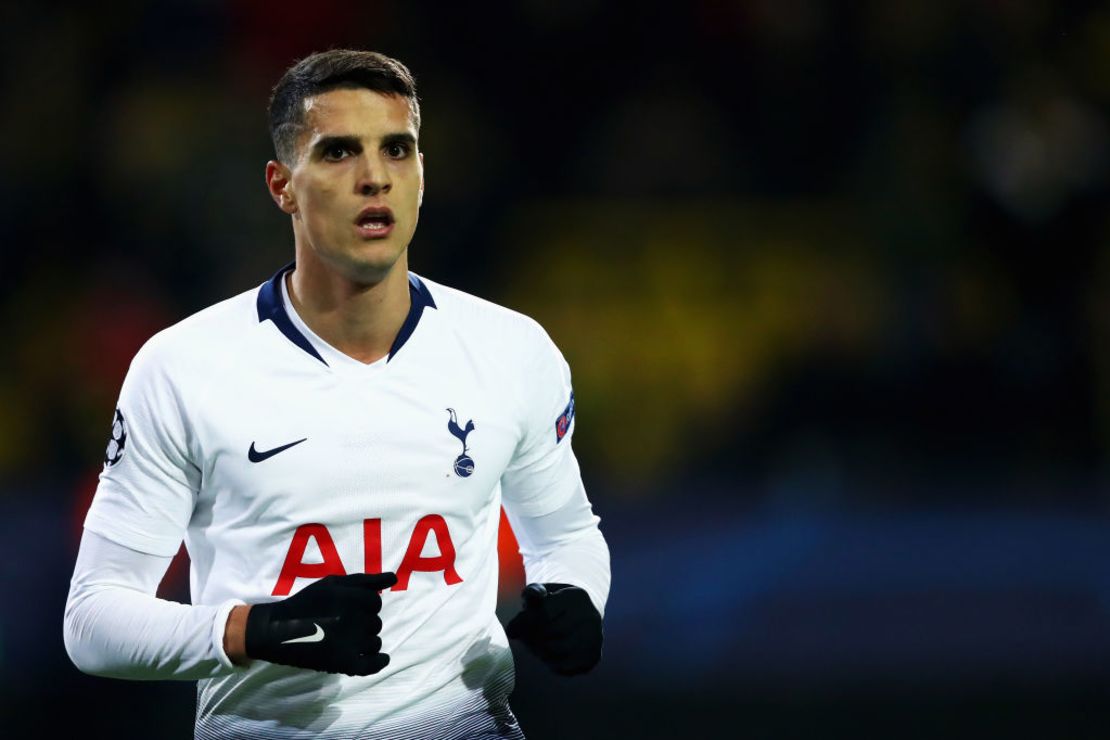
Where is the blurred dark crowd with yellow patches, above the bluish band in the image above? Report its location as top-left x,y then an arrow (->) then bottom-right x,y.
0,0 -> 1110,512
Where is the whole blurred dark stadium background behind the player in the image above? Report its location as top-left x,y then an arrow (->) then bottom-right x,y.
0,0 -> 1110,740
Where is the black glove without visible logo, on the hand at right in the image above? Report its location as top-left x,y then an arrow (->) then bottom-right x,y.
505,584 -> 602,676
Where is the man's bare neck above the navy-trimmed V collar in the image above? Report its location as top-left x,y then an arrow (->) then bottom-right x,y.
285,255 -> 412,363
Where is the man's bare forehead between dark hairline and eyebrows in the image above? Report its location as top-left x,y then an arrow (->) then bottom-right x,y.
302,88 -> 416,143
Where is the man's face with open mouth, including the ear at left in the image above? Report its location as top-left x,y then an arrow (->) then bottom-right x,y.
266,89 -> 424,284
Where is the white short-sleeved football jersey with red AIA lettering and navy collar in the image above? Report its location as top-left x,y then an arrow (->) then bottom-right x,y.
85,264 -> 590,739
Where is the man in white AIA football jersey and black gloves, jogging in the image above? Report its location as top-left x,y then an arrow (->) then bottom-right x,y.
64,50 -> 609,740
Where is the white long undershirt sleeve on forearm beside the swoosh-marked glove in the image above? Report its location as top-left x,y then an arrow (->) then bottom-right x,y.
63,529 -> 241,680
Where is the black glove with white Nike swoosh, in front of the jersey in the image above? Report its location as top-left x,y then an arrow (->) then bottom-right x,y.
246,572 -> 397,676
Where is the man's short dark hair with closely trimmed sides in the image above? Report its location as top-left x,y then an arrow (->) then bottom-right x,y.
269,49 -> 420,164
